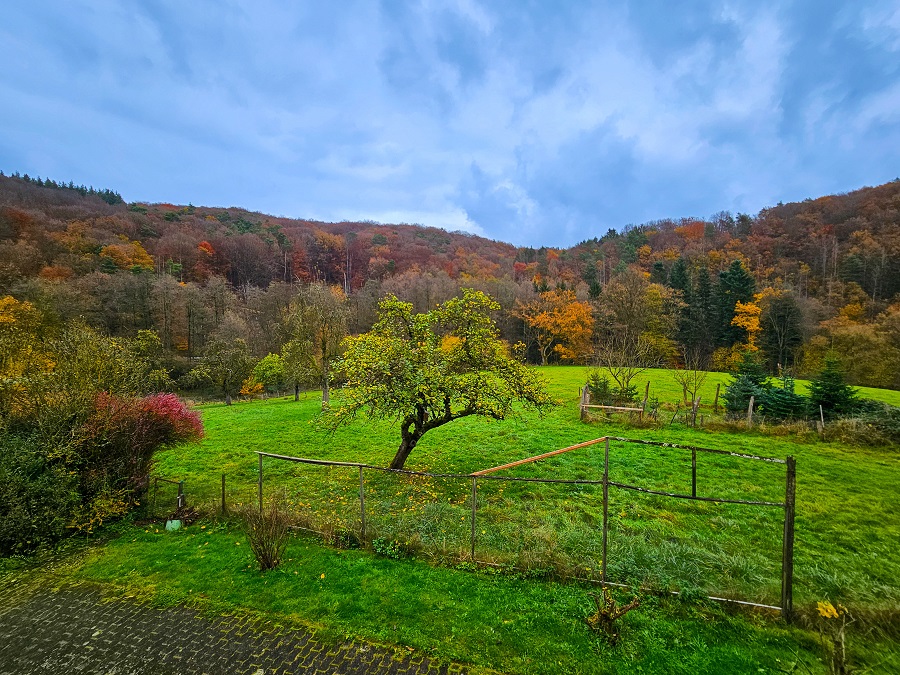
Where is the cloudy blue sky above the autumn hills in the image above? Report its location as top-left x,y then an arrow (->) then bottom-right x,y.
0,0 -> 900,247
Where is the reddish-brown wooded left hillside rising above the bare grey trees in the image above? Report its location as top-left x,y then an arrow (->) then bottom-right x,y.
0,170 -> 516,291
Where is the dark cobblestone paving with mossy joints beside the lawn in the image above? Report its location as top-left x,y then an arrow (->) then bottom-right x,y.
0,579 -> 466,675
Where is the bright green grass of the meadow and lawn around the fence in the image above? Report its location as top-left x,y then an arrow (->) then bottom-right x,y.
59,368 -> 900,673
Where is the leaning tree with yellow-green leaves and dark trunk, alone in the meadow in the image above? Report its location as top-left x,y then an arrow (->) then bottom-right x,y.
323,289 -> 553,469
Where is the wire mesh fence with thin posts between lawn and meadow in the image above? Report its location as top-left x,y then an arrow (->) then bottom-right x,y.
151,437 -> 794,615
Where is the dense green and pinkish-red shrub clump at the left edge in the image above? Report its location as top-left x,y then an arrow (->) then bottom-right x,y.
0,393 -> 203,555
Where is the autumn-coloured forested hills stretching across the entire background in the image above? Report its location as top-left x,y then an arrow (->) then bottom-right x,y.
0,176 -> 900,386
